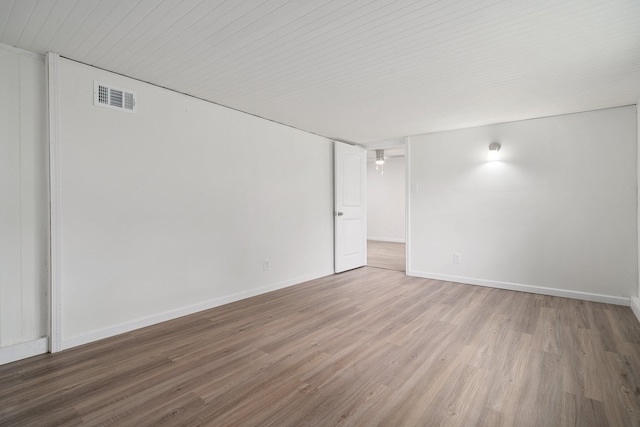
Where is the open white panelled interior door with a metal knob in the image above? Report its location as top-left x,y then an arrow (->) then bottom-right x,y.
333,141 -> 367,273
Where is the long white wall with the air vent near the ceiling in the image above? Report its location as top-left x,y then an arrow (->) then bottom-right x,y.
59,59 -> 333,347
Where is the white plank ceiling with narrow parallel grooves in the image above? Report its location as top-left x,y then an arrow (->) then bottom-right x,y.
0,0 -> 640,143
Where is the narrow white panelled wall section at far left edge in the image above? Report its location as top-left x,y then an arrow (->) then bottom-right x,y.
0,45 -> 49,363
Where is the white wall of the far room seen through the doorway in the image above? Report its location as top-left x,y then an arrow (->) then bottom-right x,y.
367,157 -> 406,242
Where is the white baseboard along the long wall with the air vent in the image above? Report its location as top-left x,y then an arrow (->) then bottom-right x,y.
62,271 -> 333,350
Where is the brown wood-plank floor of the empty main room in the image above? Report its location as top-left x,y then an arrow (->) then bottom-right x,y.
0,267 -> 640,426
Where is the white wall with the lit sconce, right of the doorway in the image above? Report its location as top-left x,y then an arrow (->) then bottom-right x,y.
409,106 -> 638,304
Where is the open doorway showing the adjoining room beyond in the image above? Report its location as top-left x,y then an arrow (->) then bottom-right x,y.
367,144 -> 406,271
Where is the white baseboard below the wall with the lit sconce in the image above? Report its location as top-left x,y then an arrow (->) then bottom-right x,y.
407,270 -> 640,308
